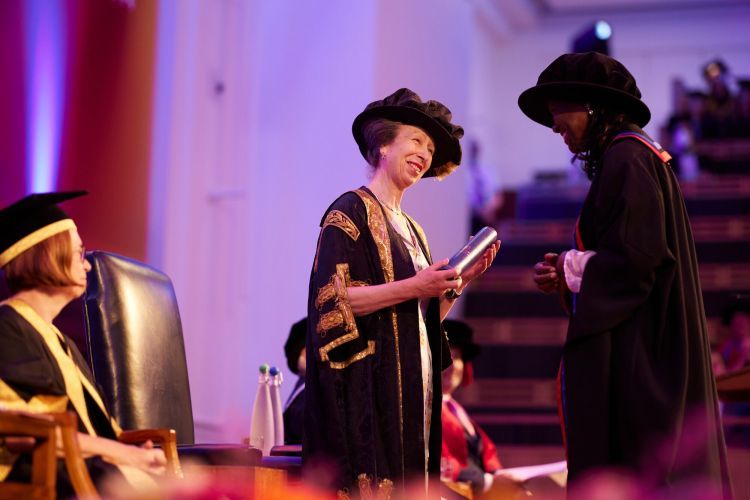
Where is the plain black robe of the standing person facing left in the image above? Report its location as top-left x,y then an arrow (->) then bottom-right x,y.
562,131 -> 728,494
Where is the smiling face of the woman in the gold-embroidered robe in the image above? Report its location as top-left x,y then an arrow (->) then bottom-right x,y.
378,125 -> 435,190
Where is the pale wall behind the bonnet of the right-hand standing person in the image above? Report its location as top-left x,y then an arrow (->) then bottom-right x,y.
470,6 -> 750,186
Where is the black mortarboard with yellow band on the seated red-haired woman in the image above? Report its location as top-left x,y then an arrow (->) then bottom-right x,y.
0,191 -> 86,267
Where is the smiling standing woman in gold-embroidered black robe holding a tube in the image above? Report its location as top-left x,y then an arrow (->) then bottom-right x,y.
303,89 -> 499,496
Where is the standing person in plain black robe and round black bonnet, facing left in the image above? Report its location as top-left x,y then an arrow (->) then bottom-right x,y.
518,52 -> 730,495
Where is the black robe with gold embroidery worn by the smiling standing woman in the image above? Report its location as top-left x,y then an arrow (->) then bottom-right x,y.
303,188 -> 451,495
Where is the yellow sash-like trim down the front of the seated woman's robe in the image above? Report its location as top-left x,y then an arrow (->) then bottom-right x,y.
1,299 -> 122,436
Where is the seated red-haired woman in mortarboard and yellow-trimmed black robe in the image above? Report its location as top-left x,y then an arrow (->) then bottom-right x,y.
0,192 -> 166,495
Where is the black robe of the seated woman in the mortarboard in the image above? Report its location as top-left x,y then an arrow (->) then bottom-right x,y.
0,305 -> 117,497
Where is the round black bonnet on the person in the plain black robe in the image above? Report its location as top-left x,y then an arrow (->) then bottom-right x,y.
518,52 -> 651,127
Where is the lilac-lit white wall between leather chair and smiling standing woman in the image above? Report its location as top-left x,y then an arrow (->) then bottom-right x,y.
149,0 -> 470,441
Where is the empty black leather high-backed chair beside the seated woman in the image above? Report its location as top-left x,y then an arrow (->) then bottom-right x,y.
84,251 -> 261,465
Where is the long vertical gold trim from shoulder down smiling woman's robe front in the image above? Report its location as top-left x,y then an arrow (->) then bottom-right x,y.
354,189 -> 406,477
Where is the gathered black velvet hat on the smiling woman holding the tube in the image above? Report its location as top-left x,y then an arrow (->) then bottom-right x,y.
352,88 -> 464,179
